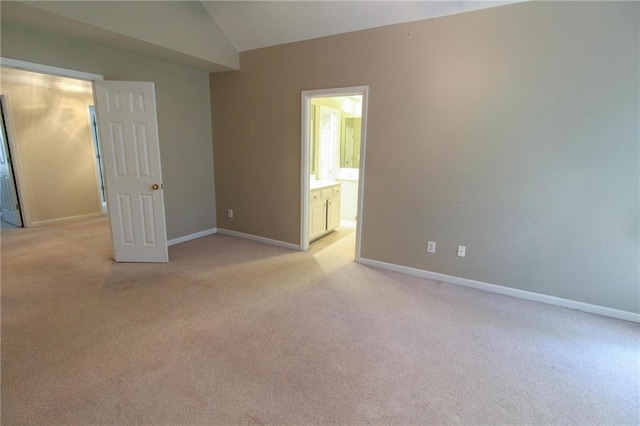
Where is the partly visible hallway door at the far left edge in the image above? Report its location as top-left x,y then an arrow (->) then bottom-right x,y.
0,100 -> 22,227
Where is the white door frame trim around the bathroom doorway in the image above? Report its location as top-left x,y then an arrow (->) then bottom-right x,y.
300,86 -> 369,262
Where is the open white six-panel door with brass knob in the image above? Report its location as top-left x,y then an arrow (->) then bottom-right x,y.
94,80 -> 169,262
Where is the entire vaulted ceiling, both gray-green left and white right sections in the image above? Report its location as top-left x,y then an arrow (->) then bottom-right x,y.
0,0 -> 523,72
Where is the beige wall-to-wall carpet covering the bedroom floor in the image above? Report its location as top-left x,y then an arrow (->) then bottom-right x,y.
1,219 -> 640,425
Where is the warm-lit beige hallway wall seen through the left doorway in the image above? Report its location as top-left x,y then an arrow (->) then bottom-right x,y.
1,63 -> 105,227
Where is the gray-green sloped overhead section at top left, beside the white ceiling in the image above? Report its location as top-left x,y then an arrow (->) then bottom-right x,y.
10,0 -> 239,71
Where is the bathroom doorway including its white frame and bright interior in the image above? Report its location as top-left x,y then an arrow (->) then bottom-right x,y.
300,86 -> 369,262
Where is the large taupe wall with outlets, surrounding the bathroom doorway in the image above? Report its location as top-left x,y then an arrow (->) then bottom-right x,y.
211,2 -> 640,313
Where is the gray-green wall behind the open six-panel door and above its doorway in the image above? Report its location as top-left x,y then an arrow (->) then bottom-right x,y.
1,21 -> 216,238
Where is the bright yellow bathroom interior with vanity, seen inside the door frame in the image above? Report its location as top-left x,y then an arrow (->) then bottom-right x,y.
308,95 -> 362,246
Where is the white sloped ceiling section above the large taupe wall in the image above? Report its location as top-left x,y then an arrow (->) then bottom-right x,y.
202,0 -> 523,52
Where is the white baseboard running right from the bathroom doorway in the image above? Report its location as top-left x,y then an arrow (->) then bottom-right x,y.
358,257 -> 640,323
